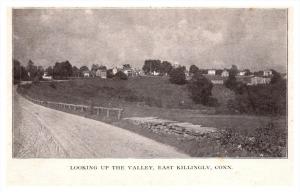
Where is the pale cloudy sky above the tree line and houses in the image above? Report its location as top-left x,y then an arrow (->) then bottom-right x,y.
13,8 -> 287,72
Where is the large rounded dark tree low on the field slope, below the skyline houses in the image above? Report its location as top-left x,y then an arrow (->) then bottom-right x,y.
187,72 -> 217,106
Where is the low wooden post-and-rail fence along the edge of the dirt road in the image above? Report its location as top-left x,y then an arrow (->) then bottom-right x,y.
25,96 -> 123,120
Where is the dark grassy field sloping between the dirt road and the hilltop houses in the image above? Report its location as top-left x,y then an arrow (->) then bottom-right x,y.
18,77 -> 287,156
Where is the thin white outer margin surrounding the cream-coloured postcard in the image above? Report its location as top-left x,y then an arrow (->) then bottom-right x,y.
0,0 -> 300,191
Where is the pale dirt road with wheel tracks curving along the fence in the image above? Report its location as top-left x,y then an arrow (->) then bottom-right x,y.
13,88 -> 188,158
